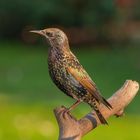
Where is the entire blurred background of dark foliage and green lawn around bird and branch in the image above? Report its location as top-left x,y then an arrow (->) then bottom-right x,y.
0,0 -> 140,140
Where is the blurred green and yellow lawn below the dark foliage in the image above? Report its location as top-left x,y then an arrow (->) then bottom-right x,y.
0,42 -> 140,140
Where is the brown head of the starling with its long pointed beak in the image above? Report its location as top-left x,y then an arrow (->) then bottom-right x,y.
30,28 -> 68,48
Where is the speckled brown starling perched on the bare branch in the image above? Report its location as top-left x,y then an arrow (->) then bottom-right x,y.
30,28 -> 112,124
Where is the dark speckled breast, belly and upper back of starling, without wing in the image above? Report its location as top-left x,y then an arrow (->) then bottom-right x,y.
48,48 -> 87,100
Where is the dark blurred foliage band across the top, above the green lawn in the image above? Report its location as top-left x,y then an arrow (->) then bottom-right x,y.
0,0 -> 140,44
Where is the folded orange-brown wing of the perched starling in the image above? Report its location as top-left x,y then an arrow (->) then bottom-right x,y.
67,67 -> 102,101
